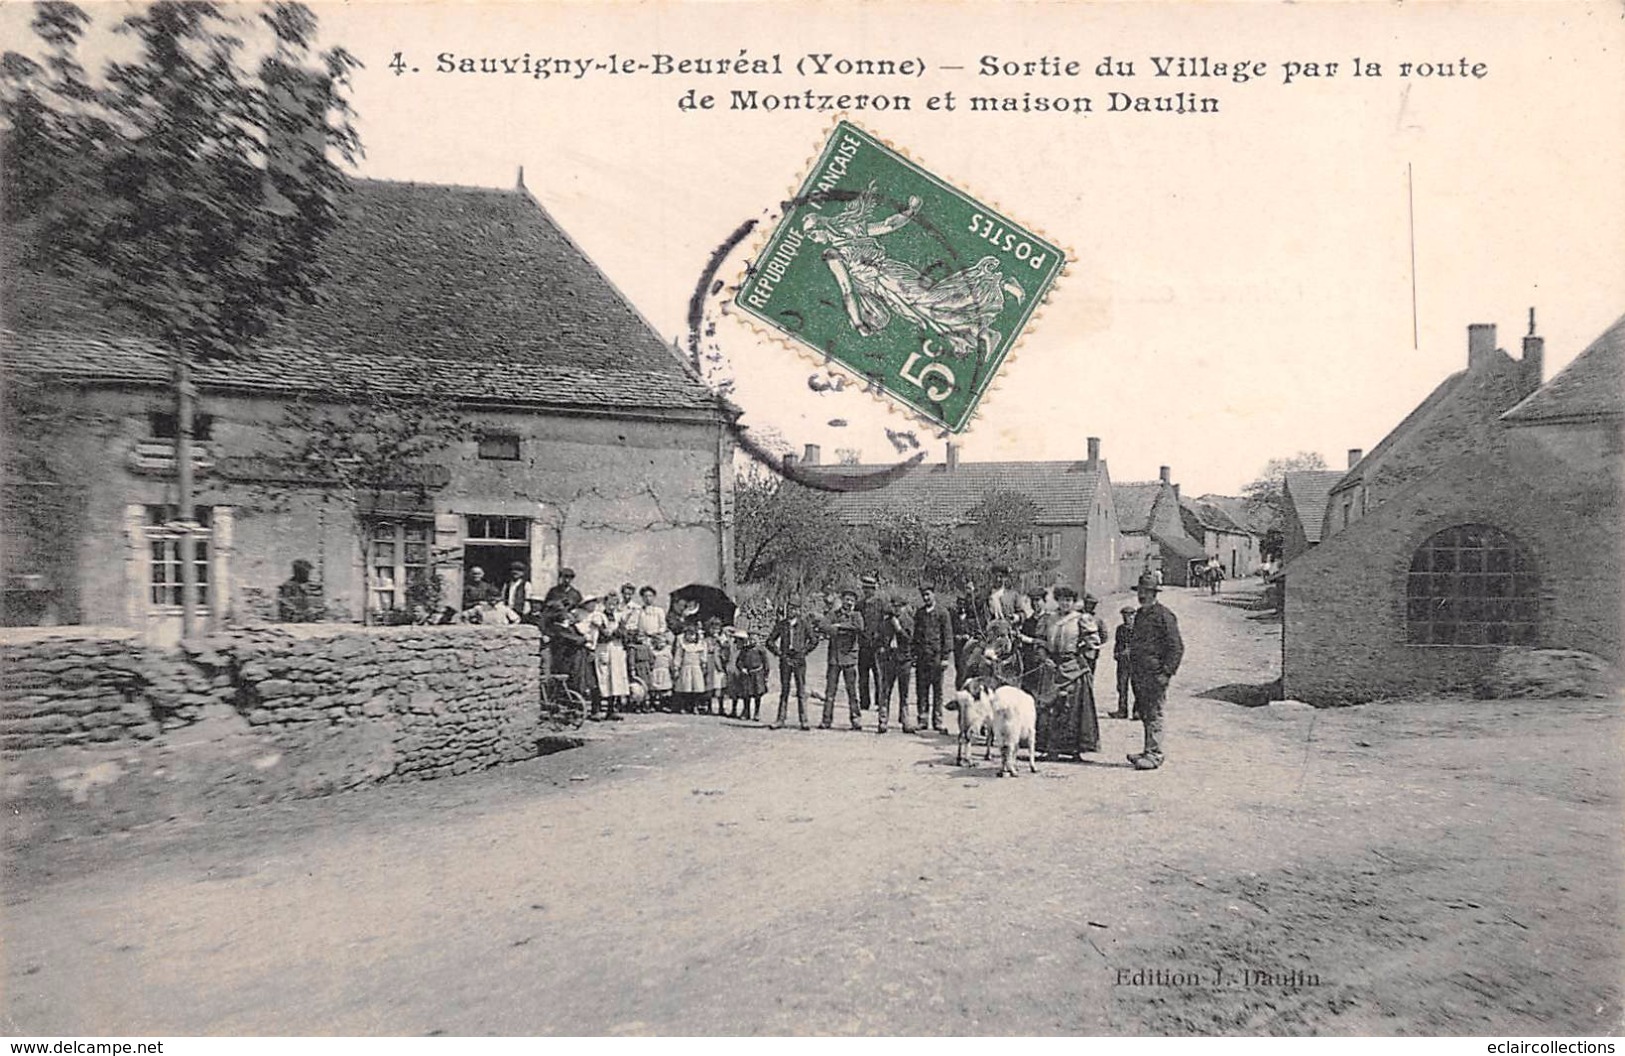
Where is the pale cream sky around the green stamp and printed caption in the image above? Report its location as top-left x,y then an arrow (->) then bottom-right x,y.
12,0 -> 1625,494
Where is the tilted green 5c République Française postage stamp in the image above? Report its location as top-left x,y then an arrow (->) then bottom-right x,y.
735,122 -> 1066,432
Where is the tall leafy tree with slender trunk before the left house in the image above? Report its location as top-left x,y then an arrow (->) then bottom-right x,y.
0,0 -> 361,634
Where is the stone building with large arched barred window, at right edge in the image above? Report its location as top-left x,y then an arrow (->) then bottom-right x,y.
1282,318 -> 1625,702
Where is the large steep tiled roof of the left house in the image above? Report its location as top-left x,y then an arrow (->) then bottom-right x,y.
0,180 -> 718,408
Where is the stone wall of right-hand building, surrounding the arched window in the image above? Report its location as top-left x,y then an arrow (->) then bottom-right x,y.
1282,432 -> 1625,703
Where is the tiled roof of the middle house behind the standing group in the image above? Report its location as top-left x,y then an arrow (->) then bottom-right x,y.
826,461 -> 1102,525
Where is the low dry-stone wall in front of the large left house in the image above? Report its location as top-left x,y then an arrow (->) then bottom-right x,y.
0,624 -> 551,830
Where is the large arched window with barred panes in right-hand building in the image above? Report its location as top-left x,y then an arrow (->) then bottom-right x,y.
1406,525 -> 1541,645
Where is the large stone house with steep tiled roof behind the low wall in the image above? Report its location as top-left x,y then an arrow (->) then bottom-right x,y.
0,180 -> 733,638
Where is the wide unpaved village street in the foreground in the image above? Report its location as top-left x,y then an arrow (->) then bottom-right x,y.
0,590 -> 1625,1037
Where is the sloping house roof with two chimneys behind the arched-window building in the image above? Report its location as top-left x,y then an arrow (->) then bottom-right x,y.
1321,310 -> 1545,539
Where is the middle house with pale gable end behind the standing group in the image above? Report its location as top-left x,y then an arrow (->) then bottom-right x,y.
832,437 -> 1120,595
